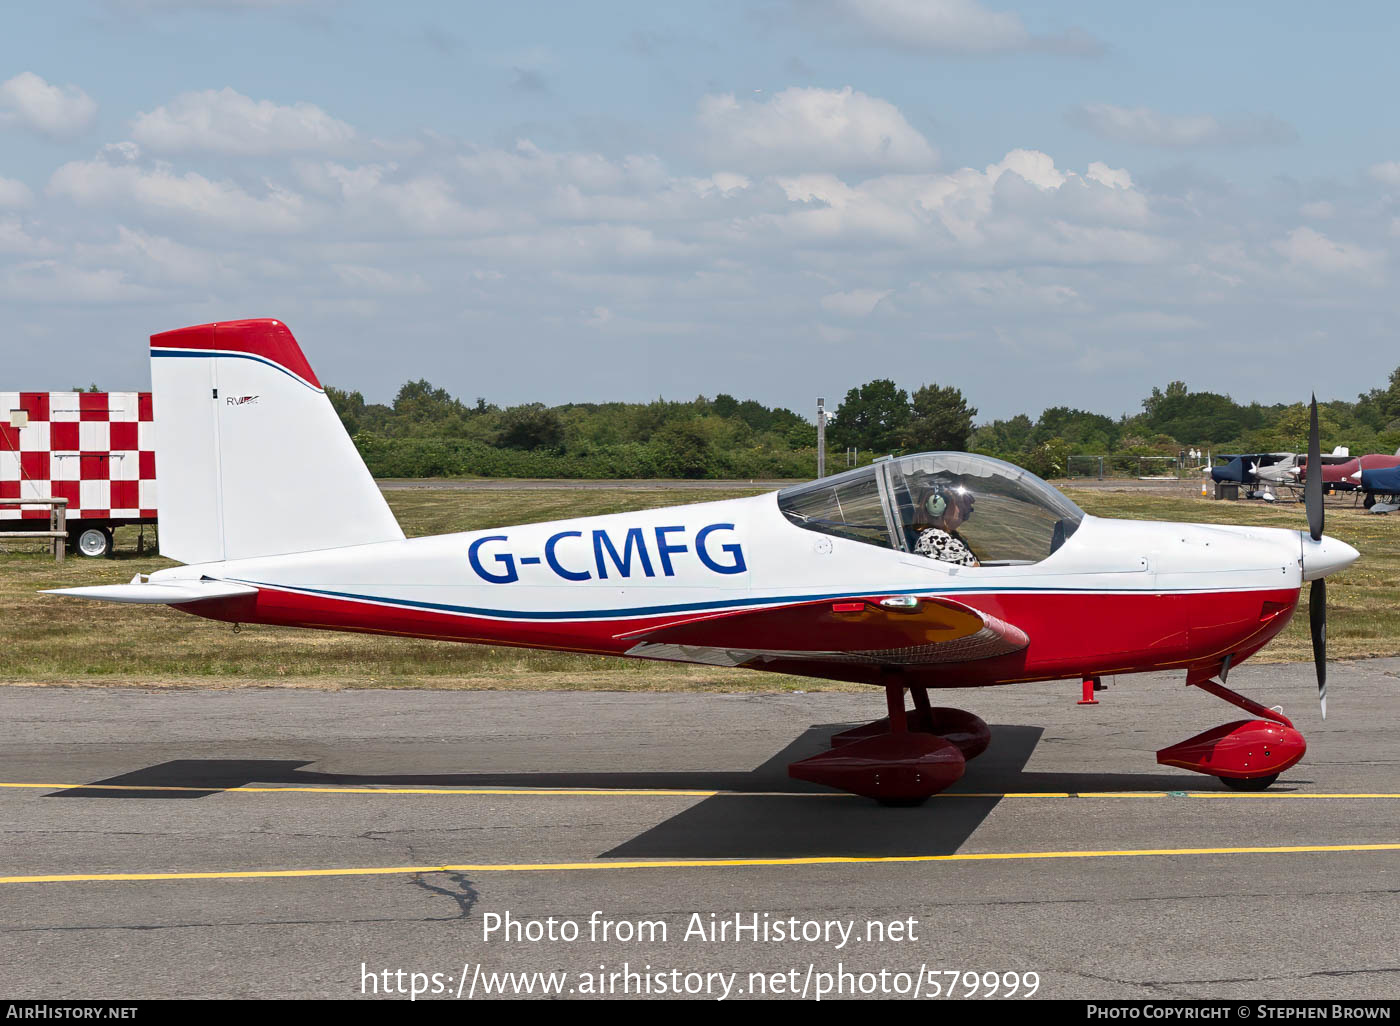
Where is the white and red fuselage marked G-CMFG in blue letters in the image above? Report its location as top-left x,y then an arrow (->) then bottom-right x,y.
151,494 -> 1321,687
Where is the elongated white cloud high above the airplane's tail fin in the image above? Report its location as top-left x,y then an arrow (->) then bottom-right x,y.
132,87 -> 356,157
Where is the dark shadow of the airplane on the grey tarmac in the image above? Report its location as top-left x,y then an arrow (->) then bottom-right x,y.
48,724 -> 1301,858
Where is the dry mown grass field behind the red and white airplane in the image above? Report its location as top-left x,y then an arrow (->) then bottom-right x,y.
0,484 -> 1400,691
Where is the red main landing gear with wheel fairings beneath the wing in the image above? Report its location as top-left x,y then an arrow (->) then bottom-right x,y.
788,684 -> 991,805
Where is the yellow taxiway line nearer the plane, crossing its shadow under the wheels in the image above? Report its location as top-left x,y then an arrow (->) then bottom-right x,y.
0,781 -> 1400,799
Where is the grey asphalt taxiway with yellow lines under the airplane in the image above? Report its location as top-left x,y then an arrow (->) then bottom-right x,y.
0,659 -> 1400,998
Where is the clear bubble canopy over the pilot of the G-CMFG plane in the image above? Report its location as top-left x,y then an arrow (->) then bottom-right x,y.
778,452 -> 1085,567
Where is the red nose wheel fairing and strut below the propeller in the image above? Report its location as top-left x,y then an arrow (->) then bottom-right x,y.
1156,676 -> 1308,791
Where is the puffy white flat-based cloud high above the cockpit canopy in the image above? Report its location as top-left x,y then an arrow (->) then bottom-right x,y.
699,85 -> 938,171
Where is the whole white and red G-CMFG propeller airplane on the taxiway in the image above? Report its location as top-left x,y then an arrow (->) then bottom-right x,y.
55,321 -> 1358,803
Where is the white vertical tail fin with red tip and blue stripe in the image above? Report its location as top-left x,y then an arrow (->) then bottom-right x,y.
151,319 -> 403,563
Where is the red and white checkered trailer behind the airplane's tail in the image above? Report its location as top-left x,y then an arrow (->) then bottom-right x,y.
0,392 -> 155,556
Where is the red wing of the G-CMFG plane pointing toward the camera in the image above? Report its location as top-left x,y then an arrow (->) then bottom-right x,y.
617,595 -> 1030,666
